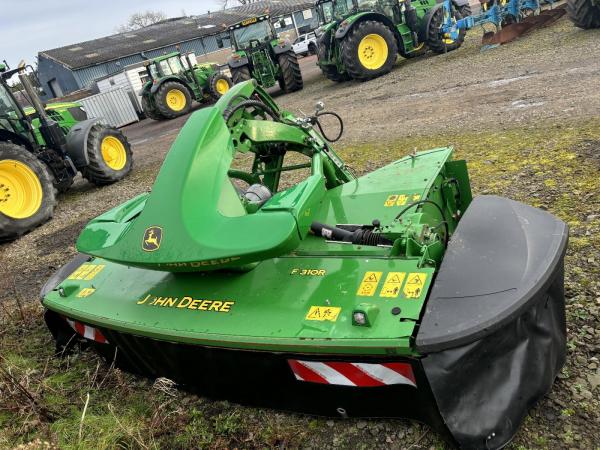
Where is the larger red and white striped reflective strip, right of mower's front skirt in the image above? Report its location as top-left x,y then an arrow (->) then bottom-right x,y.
288,359 -> 417,387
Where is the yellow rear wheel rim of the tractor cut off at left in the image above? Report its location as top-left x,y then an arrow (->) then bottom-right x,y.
0,159 -> 44,219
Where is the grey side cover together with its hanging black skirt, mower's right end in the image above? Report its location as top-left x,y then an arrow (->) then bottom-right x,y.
416,196 -> 568,449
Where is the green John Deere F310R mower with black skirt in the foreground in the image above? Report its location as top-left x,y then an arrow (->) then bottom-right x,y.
41,81 -> 568,449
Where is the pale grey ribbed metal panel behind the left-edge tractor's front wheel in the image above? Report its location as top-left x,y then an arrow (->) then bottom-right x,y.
78,89 -> 140,127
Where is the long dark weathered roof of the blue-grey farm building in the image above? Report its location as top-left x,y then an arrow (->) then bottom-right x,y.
40,0 -> 314,69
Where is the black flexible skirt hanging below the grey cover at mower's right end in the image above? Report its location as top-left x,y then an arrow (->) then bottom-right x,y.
422,269 -> 566,449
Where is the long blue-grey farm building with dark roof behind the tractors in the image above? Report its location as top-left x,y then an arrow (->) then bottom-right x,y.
38,0 -> 318,99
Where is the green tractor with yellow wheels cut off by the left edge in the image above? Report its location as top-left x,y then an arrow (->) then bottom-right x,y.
0,63 -> 133,241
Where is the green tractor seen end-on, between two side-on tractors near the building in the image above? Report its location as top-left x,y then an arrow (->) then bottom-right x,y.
223,16 -> 304,93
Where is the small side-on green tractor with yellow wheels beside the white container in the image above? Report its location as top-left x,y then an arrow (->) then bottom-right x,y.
142,52 -> 232,120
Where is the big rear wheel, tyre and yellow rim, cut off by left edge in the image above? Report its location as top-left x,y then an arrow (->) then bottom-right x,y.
0,142 -> 56,241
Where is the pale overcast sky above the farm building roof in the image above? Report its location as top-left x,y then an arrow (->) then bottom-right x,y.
0,0 -> 223,67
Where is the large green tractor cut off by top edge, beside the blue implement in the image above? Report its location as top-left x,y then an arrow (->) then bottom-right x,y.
316,0 -> 470,81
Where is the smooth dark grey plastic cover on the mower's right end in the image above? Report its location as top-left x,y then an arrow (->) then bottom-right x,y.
416,196 -> 568,353
